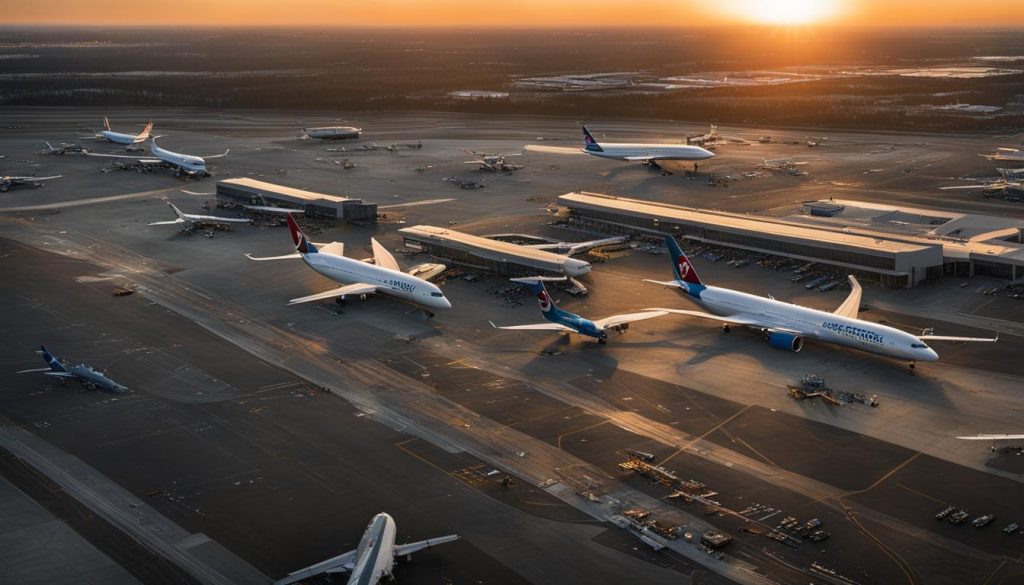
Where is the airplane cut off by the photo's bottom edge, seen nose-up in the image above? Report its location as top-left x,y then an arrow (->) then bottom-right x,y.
273,512 -> 459,585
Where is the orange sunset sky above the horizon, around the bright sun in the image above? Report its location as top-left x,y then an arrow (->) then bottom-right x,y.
0,0 -> 1024,28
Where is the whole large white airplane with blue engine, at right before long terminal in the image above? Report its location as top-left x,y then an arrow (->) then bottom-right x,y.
644,236 -> 998,369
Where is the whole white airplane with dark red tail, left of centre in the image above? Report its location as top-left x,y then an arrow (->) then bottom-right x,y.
246,215 -> 452,317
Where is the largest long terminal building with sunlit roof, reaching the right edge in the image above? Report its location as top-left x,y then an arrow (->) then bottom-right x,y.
558,193 -> 1024,288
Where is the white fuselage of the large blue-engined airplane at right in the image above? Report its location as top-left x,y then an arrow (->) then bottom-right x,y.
687,285 -> 939,362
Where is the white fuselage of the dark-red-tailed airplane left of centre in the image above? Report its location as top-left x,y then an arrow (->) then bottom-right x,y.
302,249 -> 452,309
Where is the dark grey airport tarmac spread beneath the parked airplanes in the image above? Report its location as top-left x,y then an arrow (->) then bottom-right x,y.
0,110 -> 1024,584
